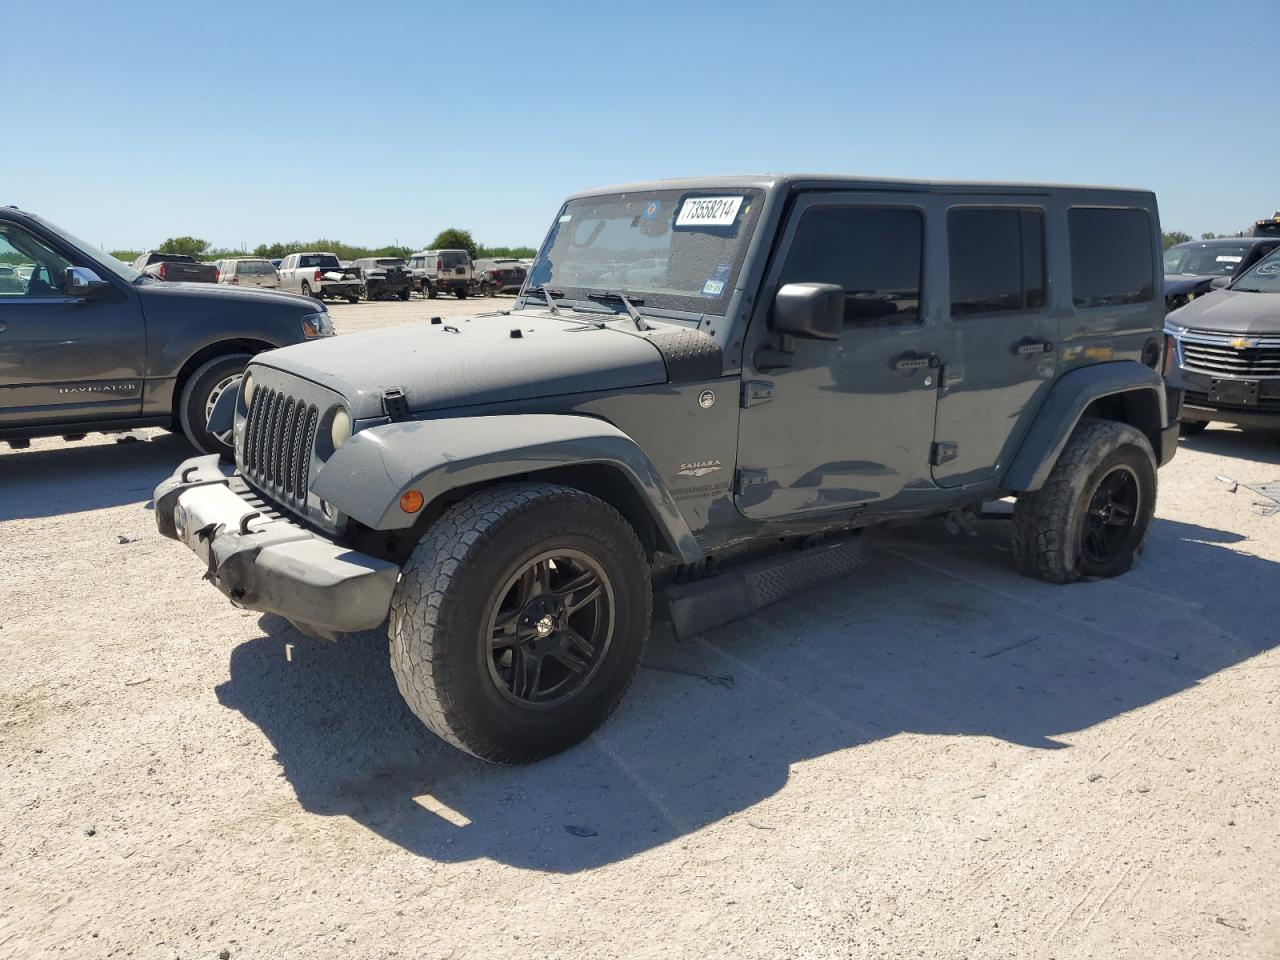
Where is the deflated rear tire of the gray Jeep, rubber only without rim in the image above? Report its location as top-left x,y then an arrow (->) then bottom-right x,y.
1012,419 -> 1156,584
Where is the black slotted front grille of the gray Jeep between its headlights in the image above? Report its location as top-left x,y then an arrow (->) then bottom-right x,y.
241,387 -> 320,508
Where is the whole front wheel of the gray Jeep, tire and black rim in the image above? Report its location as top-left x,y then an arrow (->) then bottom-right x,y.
389,483 -> 652,763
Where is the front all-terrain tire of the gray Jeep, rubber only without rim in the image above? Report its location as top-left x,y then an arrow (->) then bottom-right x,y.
388,483 -> 652,763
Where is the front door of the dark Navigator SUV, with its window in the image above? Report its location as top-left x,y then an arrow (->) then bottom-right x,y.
0,220 -> 146,429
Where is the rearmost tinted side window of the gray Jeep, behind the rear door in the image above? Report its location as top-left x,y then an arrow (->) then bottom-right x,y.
1068,207 -> 1155,307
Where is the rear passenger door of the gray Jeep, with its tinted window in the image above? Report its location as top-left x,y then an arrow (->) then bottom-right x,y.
933,197 -> 1061,486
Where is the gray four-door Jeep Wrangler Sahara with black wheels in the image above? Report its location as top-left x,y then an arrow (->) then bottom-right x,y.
156,175 -> 1178,762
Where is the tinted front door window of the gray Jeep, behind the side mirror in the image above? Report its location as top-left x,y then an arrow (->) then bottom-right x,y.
782,207 -> 924,325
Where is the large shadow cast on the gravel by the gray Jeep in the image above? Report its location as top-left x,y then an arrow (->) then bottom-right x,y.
218,521 -> 1280,872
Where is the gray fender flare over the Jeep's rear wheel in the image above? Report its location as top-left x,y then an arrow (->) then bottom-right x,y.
1001,360 -> 1169,493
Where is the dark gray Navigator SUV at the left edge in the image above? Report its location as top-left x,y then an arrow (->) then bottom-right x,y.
0,206 -> 333,457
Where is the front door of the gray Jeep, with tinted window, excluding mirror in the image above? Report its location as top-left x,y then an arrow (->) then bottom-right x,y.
737,193 -> 942,520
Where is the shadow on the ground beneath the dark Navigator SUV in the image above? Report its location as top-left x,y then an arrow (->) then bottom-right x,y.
0,434 -> 198,522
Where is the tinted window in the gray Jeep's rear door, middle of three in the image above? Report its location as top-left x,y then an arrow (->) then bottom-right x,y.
947,207 -> 1044,316
